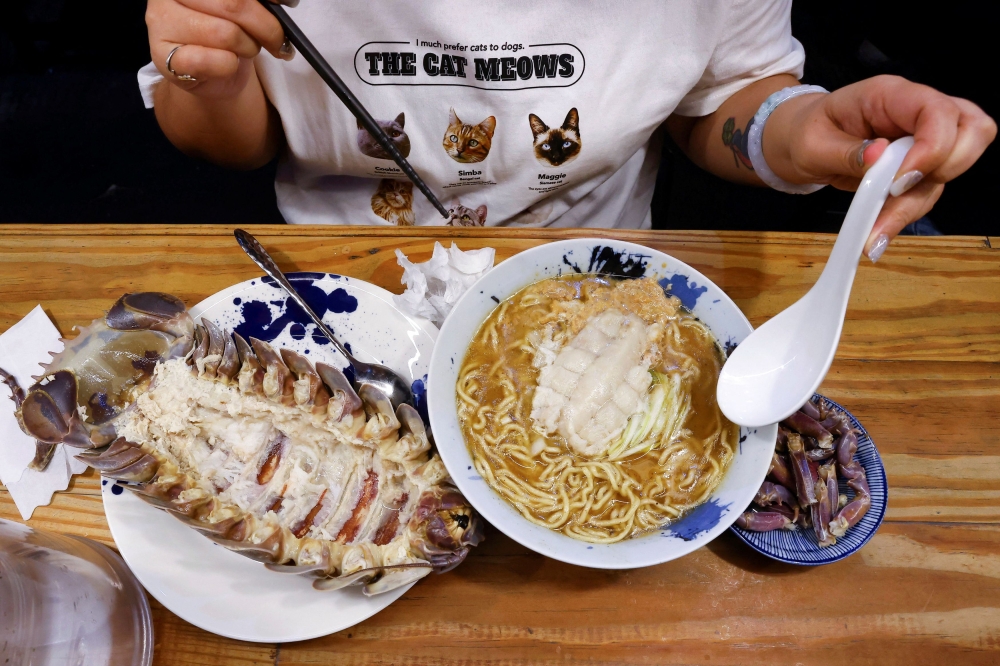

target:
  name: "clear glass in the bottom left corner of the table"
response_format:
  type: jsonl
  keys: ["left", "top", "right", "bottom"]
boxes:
{"left": 0, "top": 519, "right": 153, "bottom": 666}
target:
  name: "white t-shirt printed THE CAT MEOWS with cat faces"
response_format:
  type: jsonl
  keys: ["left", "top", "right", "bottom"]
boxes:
{"left": 139, "top": 0, "right": 805, "bottom": 228}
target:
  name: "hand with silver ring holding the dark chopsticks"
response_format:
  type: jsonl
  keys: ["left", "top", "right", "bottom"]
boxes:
{"left": 146, "top": 0, "right": 294, "bottom": 98}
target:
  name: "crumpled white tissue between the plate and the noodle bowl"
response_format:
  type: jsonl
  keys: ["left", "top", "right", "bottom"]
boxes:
{"left": 392, "top": 242, "right": 496, "bottom": 326}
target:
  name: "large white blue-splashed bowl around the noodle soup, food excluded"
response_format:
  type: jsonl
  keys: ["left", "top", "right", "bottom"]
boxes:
{"left": 427, "top": 238, "right": 777, "bottom": 569}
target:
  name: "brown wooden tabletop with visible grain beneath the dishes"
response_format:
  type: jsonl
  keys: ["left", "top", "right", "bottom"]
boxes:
{"left": 0, "top": 226, "right": 1000, "bottom": 666}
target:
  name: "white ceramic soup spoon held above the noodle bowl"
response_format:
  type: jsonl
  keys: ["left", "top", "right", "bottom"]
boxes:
{"left": 716, "top": 137, "right": 913, "bottom": 427}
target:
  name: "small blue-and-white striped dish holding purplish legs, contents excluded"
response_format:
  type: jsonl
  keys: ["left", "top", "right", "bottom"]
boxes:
{"left": 730, "top": 394, "right": 889, "bottom": 566}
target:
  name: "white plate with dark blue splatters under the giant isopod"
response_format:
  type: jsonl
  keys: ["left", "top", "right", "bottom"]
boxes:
{"left": 102, "top": 273, "right": 437, "bottom": 643}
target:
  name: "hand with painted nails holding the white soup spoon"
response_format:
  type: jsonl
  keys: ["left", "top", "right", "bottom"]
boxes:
{"left": 762, "top": 76, "right": 997, "bottom": 261}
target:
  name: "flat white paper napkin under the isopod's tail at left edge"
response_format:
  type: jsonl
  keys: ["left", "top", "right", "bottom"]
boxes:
{"left": 0, "top": 305, "right": 87, "bottom": 520}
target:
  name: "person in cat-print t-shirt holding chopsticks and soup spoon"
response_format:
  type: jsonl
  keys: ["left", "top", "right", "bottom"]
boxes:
{"left": 139, "top": 0, "right": 996, "bottom": 261}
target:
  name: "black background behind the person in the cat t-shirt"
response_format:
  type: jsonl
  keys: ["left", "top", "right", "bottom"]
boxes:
{"left": 0, "top": 0, "right": 1000, "bottom": 234}
